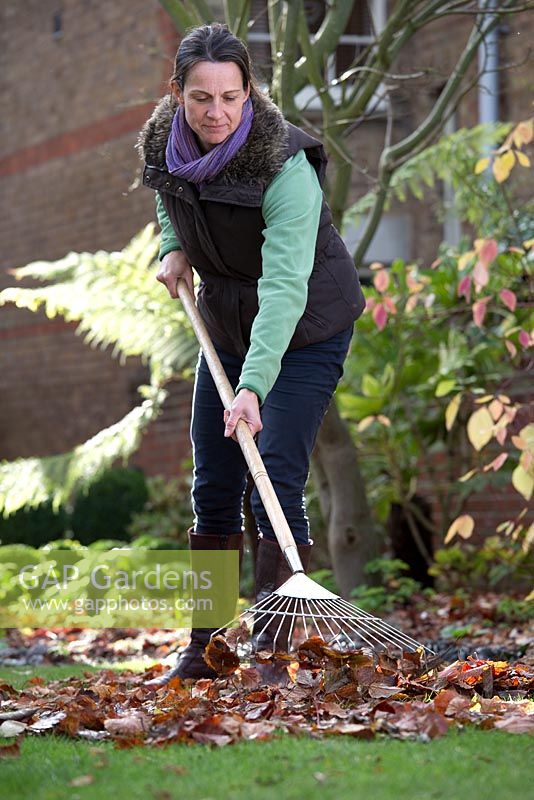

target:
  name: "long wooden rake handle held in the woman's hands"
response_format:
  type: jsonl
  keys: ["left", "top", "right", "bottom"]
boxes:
{"left": 177, "top": 278, "right": 304, "bottom": 573}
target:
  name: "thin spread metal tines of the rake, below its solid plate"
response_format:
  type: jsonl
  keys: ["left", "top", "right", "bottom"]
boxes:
{"left": 245, "top": 592, "right": 427, "bottom": 651}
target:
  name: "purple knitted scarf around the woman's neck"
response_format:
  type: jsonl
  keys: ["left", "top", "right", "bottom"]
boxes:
{"left": 165, "top": 97, "right": 254, "bottom": 184}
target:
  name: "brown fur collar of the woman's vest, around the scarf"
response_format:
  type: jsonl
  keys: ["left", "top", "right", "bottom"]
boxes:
{"left": 136, "top": 94, "right": 288, "bottom": 186}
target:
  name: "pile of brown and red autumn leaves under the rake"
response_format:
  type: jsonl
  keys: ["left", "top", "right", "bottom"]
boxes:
{"left": 0, "top": 638, "right": 534, "bottom": 755}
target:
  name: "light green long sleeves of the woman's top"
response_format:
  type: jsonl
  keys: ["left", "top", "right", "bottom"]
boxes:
{"left": 156, "top": 150, "right": 322, "bottom": 403}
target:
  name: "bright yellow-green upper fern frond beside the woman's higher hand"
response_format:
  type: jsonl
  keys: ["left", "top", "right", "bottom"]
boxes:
{"left": 0, "top": 225, "right": 198, "bottom": 375}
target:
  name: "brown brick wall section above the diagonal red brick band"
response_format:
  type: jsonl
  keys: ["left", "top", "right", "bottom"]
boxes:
{"left": 1, "top": 0, "right": 172, "bottom": 154}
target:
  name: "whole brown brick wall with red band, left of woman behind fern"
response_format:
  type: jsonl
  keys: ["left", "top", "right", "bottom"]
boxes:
{"left": 0, "top": 0, "right": 190, "bottom": 475}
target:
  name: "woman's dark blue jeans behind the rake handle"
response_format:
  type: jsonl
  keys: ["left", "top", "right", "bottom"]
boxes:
{"left": 191, "top": 326, "right": 352, "bottom": 544}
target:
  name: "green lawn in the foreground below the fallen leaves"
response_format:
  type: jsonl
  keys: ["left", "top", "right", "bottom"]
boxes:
{"left": 0, "top": 665, "right": 534, "bottom": 800}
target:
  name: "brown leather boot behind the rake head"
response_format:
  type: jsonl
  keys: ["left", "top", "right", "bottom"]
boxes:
{"left": 252, "top": 537, "right": 313, "bottom": 684}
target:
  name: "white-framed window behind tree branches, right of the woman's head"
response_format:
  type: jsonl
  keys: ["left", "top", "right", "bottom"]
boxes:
{"left": 248, "top": 0, "right": 386, "bottom": 110}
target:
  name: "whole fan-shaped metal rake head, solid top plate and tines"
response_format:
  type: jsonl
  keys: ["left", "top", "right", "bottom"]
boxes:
{"left": 214, "top": 572, "right": 433, "bottom": 655}
